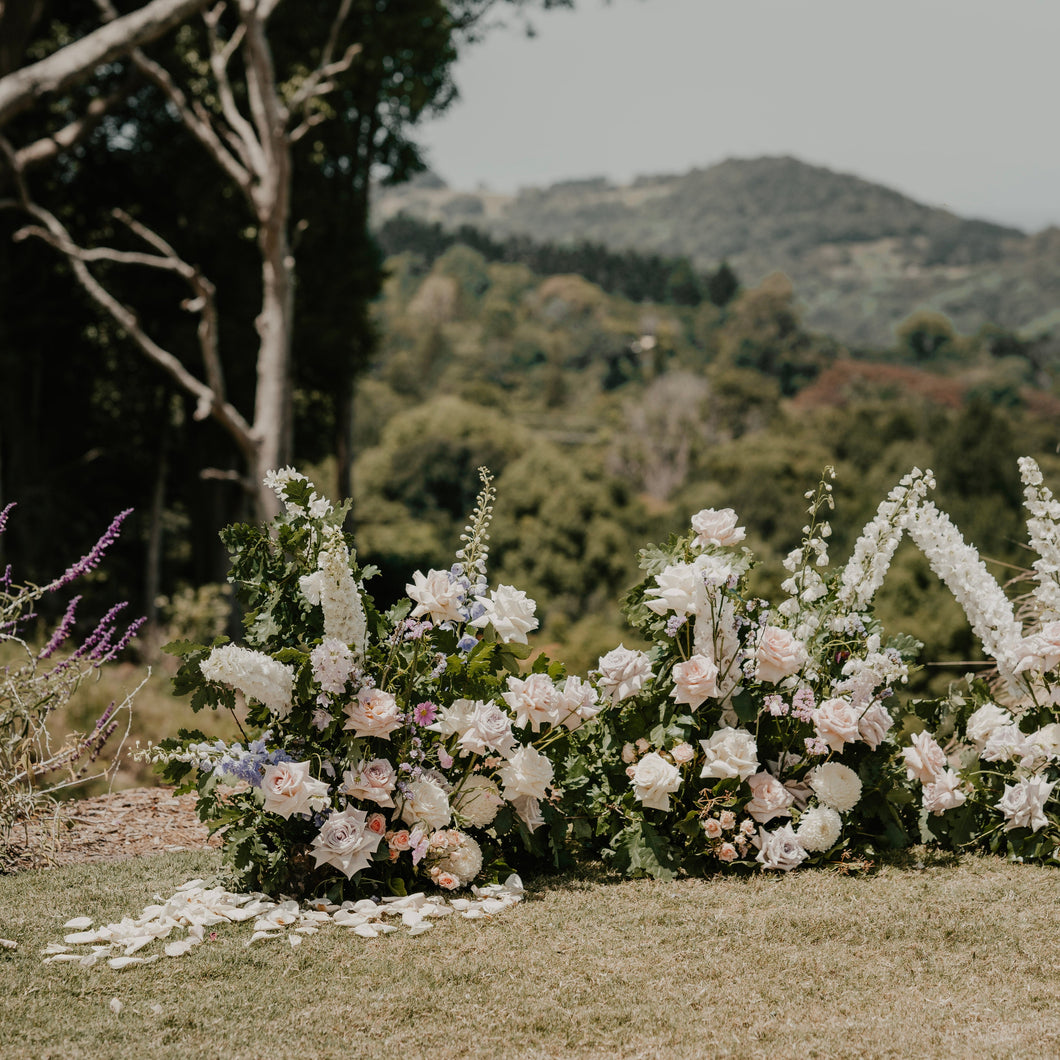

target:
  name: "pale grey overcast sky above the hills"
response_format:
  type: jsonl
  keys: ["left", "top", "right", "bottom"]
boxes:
{"left": 421, "top": 0, "right": 1060, "bottom": 231}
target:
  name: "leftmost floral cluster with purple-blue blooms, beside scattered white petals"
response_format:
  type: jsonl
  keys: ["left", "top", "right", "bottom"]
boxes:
{"left": 152, "top": 469, "right": 599, "bottom": 902}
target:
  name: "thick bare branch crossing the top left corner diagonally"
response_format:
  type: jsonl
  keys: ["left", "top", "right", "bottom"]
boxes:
{"left": 0, "top": 0, "right": 213, "bottom": 126}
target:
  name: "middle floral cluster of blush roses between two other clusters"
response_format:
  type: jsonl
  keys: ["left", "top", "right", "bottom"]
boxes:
{"left": 566, "top": 470, "right": 933, "bottom": 879}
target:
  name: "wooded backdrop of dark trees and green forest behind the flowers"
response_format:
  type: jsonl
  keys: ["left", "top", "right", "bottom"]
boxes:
{"left": 0, "top": 0, "right": 1060, "bottom": 703}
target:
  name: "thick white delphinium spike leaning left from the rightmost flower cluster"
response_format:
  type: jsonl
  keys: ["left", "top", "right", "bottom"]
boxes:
{"left": 904, "top": 501, "right": 1023, "bottom": 692}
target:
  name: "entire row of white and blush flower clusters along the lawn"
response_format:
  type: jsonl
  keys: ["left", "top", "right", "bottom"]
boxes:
{"left": 140, "top": 453, "right": 1060, "bottom": 903}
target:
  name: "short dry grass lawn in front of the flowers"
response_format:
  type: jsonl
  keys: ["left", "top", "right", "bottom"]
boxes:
{"left": 0, "top": 853, "right": 1060, "bottom": 1060}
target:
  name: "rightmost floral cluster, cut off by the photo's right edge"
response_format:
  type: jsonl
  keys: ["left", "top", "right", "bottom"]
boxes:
{"left": 902, "top": 457, "right": 1060, "bottom": 864}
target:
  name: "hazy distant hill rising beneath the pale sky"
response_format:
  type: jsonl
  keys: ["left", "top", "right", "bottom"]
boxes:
{"left": 373, "top": 157, "right": 1060, "bottom": 347}
